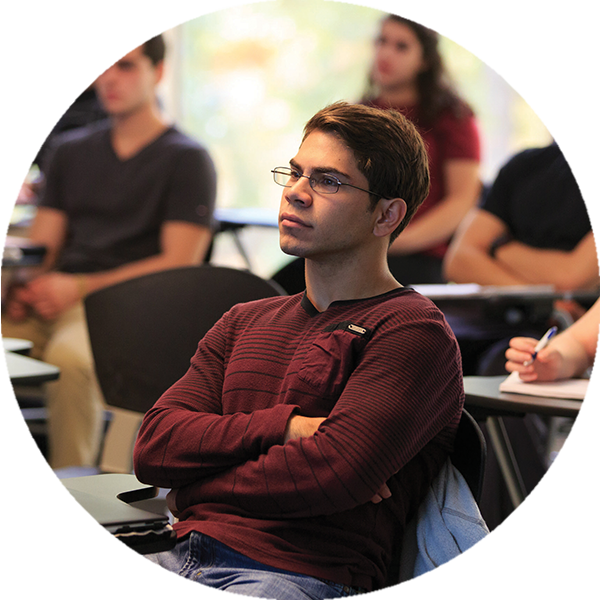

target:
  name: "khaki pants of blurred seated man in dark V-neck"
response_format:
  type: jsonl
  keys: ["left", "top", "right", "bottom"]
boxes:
{"left": 2, "top": 303, "right": 104, "bottom": 468}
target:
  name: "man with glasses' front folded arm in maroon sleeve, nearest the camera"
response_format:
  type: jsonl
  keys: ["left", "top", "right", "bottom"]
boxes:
{"left": 176, "top": 324, "right": 463, "bottom": 518}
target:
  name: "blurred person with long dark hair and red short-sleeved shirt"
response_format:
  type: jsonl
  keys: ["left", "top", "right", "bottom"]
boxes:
{"left": 362, "top": 8, "right": 481, "bottom": 285}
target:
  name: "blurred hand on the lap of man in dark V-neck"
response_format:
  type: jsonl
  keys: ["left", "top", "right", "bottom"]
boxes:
{"left": 27, "top": 272, "right": 82, "bottom": 320}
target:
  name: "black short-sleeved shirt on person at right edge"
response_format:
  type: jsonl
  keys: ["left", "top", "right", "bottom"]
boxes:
{"left": 482, "top": 142, "right": 600, "bottom": 252}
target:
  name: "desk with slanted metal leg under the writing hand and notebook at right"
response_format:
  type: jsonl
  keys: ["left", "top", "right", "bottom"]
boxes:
{"left": 464, "top": 375, "right": 600, "bottom": 526}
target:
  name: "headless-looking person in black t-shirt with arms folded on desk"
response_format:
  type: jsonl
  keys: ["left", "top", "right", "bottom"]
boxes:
{"left": 445, "top": 21, "right": 600, "bottom": 290}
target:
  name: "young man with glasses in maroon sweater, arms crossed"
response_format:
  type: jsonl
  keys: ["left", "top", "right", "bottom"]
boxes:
{"left": 80, "top": 103, "right": 464, "bottom": 600}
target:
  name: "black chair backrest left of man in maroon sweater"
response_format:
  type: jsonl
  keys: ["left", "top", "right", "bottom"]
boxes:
{"left": 85, "top": 265, "right": 281, "bottom": 413}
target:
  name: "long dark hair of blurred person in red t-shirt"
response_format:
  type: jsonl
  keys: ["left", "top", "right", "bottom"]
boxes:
{"left": 362, "top": 8, "right": 473, "bottom": 124}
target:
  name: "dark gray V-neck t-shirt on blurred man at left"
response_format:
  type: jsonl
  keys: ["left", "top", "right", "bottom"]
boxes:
{"left": 40, "top": 123, "right": 216, "bottom": 273}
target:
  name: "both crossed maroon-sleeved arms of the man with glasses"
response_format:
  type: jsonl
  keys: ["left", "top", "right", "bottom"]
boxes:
{"left": 134, "top": 304, "right": 462, "bottom": 518}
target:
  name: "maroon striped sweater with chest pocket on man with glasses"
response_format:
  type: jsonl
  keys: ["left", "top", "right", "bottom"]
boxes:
{"left": 134, "top": 288, "right": 464, "bottom": 589}
